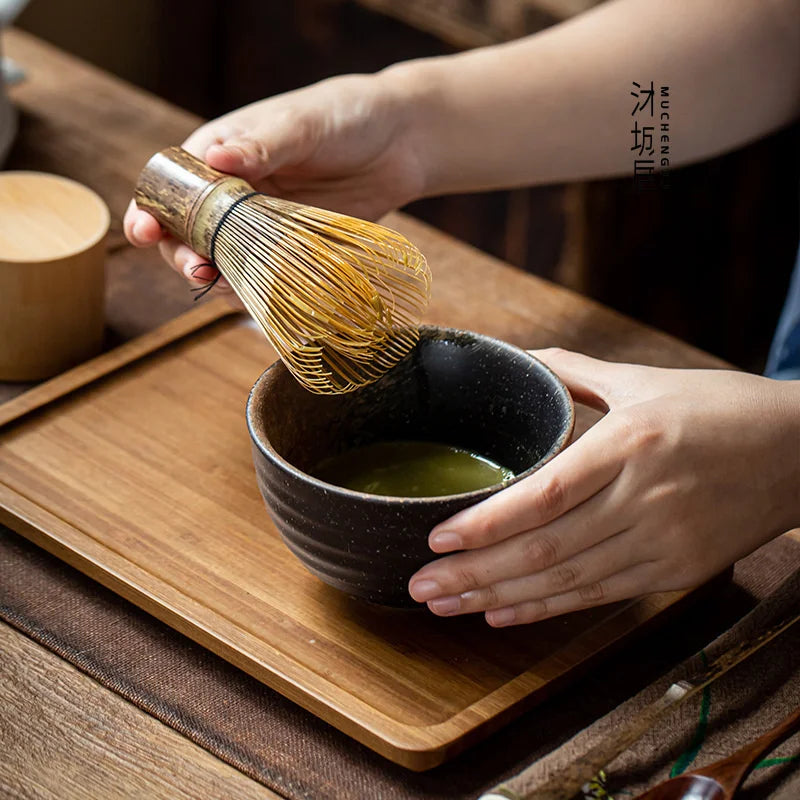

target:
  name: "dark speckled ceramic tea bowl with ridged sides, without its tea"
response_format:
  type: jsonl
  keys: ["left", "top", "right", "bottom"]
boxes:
{"left": 247, "top": 326, "right": 574, "bottom": 606}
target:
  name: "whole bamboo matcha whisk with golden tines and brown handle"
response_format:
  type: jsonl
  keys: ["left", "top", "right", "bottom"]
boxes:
{"left": 136, "top": 147, "right": 430, "bottom": 394}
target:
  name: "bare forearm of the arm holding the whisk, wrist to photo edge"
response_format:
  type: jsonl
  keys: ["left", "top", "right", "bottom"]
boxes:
{"left": 381, "top": 0, "right": 800, "bottom": 194}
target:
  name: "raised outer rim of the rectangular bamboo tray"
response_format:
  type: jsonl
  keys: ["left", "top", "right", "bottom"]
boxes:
{"left": 0, "top": 299, "right": 708, "bottom": 771}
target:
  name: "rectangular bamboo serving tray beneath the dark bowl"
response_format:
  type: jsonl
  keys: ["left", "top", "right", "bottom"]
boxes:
{"left": 0, "top": 301, "right": 708, "bottom": 770}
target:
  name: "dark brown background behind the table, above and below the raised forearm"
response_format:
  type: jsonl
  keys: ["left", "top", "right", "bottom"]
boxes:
{"left": 19, "top": 0, "right": 800, "bottom": 370}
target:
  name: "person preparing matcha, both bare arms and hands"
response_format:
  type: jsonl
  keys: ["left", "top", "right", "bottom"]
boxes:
{"left": 125, "top": 0, "right": 800, "bottom": 625}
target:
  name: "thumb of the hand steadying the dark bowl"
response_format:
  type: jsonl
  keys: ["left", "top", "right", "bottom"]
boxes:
{"left": 528, "top": 347, "right": 659, "bottom": 411}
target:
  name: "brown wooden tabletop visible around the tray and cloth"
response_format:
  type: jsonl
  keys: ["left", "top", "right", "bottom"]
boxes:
{"left": 0, "top": 31, "right": 736, "bottom": 800}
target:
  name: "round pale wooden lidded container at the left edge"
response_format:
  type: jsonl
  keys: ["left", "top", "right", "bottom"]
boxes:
{"left": 0, "top": 172, "right": 110, "bottom": 381}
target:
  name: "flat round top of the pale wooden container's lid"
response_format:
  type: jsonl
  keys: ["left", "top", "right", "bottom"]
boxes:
{"left": 0, "top": 171, "right": 110, "bottom": 263}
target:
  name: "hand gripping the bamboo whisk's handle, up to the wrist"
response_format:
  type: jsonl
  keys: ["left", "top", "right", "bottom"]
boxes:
{"left": 125, "top": 75, "right": 432, "bottom": 289}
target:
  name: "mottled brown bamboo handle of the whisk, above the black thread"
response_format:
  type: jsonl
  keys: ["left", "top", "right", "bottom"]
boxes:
{"left": 134, "top": 147, "right": 254, "bottom": 258}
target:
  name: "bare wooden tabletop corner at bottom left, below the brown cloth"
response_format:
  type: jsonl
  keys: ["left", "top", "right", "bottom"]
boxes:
{"left": 0, "top": 623, "right": 279, "bottom": 800}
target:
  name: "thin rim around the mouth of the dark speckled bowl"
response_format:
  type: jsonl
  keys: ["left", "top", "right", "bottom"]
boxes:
{"left": 246, "top": 325, "right": 575, "bottom": 506}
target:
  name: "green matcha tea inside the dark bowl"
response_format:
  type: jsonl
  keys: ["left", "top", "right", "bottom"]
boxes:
{"left": 313, "top": 442, "right": 514, "bottom": 497}
